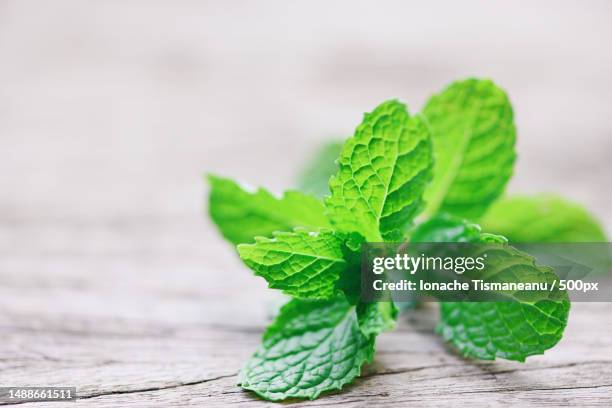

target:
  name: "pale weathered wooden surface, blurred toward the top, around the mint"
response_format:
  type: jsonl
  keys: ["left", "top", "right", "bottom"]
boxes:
{"left": 0, "top": 0, "right": 612, "bottom": 407}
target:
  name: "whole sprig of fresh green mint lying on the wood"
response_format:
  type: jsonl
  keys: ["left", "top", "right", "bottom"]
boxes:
{"left": 209, "top": 79, "right": 605, "bottom": 401}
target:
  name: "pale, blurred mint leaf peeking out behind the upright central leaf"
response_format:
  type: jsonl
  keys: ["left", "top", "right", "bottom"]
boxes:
{"left": 298, "top": 140, "right": 342, "bottom": 198}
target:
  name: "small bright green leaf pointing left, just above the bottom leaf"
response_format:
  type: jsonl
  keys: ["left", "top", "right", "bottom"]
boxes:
{"left": 238, "top": 229, "right": 347, "bottom": 299}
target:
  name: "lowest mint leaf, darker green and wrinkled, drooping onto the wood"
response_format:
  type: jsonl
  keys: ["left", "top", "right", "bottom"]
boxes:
{"left": 239, "top": 297, "right": 375, "bottom": 401}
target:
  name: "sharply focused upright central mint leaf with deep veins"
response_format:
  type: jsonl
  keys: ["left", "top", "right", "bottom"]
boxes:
{"left": 325, "top": 101, "right": 432, "bottom": 242}
